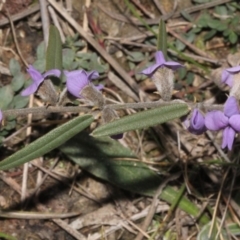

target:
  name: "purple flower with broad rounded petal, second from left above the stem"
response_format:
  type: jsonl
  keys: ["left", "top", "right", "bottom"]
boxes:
{"left": 64, "top": 70, "right": 103, "bottom": 98}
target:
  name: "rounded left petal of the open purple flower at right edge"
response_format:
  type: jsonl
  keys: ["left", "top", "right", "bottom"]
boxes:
{"left": 205, "top": 111, "right": 228, "bottom": 131}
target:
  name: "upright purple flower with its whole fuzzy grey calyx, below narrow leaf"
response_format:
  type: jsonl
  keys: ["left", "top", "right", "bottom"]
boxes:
{"left": 141, "top": 51, "right": 182, "bottom": 101}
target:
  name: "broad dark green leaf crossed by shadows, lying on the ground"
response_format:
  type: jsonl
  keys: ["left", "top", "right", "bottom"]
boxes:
{"left": 60, "top": 132, "right": 209, "bottom": 224}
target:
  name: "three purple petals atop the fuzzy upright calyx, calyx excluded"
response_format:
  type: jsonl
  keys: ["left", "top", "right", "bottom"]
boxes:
{"left": 141, "top": 51, "right": 182, "bottom": 77}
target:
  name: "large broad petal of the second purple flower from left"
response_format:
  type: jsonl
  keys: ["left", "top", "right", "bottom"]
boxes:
{"left": 64, "top": 70, "right": 89, "bottom": 98}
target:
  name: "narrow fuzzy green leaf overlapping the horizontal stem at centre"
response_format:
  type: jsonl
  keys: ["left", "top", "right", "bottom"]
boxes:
{"left": 92, "top": 103, "right": 189, "bottom": 137}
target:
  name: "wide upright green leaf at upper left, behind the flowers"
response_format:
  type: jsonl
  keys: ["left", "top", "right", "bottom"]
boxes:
{"left": 46, "top": 26, "right": 62, "bottom": 71}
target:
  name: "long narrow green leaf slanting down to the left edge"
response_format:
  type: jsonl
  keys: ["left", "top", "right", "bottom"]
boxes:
{"left": 0, "top": 115, "right": 93, "bottom": 170}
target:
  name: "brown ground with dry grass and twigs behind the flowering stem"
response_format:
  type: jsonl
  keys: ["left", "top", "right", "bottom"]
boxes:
{"left": 0, "top": 0, "right": 240, "bottom": 240}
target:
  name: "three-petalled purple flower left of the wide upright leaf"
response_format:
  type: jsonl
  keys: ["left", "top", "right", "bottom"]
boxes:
{"left": 21, "top": 65, "right": 61, "bottom": 96}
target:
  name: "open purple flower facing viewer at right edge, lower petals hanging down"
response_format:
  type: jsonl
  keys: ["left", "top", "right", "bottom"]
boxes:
{"left": 205, "top": 97, "right": 240, "bottom": 150}
